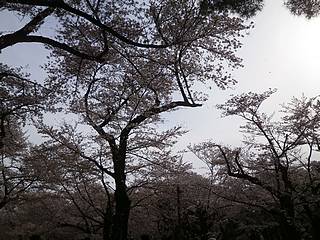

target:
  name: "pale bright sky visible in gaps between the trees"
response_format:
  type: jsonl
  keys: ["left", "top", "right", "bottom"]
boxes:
{"left": 0, "top": 0, "right": 320, "bottom": 172}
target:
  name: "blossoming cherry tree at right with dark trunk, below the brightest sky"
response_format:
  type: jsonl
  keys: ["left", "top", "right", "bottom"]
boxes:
{"left": 193, "top": 90, "right": 320, "bottom": 239}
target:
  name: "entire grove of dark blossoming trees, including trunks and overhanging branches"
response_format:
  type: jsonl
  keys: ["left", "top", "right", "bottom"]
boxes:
{"left": 0, "top": 0, "right": 320, "bottom": 240}
